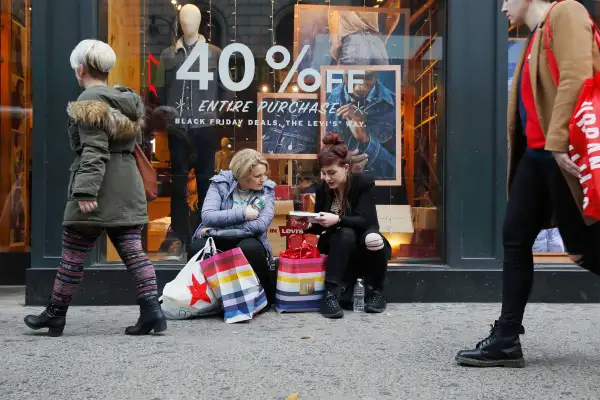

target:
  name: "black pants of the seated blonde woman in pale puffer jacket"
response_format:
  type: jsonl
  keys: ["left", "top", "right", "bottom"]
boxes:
{"left": 188, "top": 237, "right": 275, "bottom": 304}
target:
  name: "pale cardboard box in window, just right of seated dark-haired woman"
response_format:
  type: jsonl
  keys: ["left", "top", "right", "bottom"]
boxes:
{"left": 376, "top": 205, "right": 414, "bottom": 259}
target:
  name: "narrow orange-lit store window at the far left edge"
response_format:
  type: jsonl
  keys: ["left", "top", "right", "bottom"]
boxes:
{"left": 0, "top": 0, "right": 32, "bottom": 252}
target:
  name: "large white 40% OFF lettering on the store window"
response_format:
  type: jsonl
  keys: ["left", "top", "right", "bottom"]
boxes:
{"left": 176, "top": 43, "right": 365, "bottom": 93}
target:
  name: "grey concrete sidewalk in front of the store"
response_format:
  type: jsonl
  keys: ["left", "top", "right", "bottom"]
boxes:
{"left": 0, "top": 290, "right": 600, "bottom": 400}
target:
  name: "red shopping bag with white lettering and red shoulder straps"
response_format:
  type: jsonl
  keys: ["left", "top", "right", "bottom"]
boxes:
{"left": 544, "top": 3, "right": 600, "bottom": 220}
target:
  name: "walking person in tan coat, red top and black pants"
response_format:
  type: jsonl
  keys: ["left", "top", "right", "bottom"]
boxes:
{"left": 456, "top": 0, "right": 600, "bottom": 367}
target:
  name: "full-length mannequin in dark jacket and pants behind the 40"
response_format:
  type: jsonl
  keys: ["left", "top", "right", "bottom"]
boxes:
{"left": 154, "top": 4, "right": 233, "bottom": 259}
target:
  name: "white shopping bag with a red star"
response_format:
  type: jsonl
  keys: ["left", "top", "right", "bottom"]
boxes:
{"left": 159, "top": 238, "right": 223, "bottom": 319}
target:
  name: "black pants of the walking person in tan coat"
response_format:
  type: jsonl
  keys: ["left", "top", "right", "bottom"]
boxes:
{"left": 500, "top": 153, "right": 600, "bottom": 329}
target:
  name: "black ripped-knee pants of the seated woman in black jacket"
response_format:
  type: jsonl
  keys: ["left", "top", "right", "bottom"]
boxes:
{"left": 318, "top": 227, "right": 391, "bottom": 294}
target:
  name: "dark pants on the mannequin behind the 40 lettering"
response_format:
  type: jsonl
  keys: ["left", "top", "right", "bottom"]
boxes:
{"left": 167, "top": 126, "right": 217, "bottom": 246}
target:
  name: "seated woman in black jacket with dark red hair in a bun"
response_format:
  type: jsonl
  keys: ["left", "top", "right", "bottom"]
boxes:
{"left": 305, "top": 134, "right": 391, "bottom": 318}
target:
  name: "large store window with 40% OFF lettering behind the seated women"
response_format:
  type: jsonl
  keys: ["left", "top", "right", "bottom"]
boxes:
{"left": 101, "top": 0, "right": 446, "bottom": 264}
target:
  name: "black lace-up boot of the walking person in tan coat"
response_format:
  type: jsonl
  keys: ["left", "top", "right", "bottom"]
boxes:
{"left": 456, "top": 321, "right": 525, "bottom": 368}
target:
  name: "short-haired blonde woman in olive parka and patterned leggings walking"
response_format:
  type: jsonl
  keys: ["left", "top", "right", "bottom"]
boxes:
{"left": 25, "top": 40, "right": 167, "bottom": 336}
